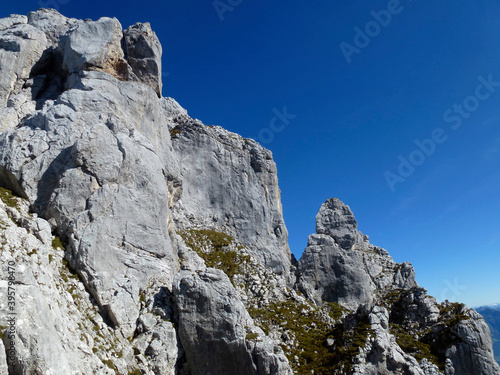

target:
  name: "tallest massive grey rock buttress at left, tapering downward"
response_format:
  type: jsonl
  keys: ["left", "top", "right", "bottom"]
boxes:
{"left": 0, "top": 11, "right": 176, "bottom": 335}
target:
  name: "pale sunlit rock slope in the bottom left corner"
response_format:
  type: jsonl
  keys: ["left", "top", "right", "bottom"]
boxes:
{"left": 0, "top": 190, "right": 126, "bottom": 375}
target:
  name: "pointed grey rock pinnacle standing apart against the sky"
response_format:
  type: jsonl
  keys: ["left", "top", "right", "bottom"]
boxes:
{"left": 299, "top": 198, "right": 417, "bottom": 309}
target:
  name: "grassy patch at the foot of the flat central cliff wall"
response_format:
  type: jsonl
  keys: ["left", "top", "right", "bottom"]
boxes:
{"left": 179, "top": 229, "right": 250, "bottom": 282}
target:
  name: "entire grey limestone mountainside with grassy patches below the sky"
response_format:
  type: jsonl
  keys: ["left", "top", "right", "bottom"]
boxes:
{"left": 0, "top": 10, "right": 500, "bottom": 375}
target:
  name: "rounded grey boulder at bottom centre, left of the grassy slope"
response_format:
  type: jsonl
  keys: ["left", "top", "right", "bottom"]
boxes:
{"left": 173, "top": 268, "right": 292, "bottom": 375}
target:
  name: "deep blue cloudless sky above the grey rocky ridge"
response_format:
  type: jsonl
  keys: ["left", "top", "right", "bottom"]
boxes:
{"left": 0, "top": 0, "right": 500, "bottom": 306}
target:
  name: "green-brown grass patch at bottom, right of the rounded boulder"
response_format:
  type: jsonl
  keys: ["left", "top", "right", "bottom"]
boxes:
{"left": 248, "top": 300, "right": 350, "bottom": 375}
